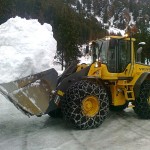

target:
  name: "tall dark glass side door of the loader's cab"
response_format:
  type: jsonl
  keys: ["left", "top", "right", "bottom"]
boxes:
{"left": 107, "top": 39, "right": 131, "bottom": 73}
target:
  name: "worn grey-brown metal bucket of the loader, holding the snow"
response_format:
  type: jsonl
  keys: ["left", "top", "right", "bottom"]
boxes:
{"left": 0, "top": 69, "right": 58, "bottom": 116}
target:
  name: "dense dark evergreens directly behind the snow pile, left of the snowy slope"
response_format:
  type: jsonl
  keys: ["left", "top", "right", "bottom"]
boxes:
{"left": 0, "top": 0, "right": 105, "bottom": 63}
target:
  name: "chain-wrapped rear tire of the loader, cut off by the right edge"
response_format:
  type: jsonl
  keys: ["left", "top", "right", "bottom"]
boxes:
{"left": 133, "top": 80, "right": 150, "bottom": 119}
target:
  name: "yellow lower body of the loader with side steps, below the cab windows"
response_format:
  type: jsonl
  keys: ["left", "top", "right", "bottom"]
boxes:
{"left": 88, "top": 63, "right": 150, "bottom": 106}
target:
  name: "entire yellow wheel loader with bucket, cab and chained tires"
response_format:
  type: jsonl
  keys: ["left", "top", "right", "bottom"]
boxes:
{"left": 0, "top": 36, "right": 150, "bottom": 129}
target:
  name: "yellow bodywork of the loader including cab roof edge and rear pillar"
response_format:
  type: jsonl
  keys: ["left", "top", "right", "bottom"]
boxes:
{"left": 77, "top": 36, "right": 150, "bottom": 106}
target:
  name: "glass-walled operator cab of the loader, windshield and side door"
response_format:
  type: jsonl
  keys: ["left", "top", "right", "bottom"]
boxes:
{"left": 91, "top": 37, "right": 131, "bottom": 73}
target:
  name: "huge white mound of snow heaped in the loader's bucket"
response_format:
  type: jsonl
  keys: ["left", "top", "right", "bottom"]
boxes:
{"left": 0, "top": 17, "right": 57, "bottom": 83}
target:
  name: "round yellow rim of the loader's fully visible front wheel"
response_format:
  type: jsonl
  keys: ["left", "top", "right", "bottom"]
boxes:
{"left": 82, "top": 96, "right": 100, "bottom": 117}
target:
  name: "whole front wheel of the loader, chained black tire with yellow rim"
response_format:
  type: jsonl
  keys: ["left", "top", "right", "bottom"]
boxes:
{"left": 62, "top": 80, "right": 109, "bottom": 129}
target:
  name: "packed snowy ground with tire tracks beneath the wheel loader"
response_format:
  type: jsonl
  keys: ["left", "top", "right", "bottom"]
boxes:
{"left": 0, "top": 95, "right": 150, "bottom": 150}
